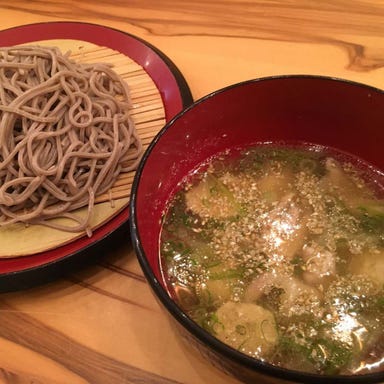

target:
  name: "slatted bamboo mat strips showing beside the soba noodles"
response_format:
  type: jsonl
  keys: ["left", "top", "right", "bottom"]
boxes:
{"left": 62, "top": 42, "right": 165, "bottom": 203}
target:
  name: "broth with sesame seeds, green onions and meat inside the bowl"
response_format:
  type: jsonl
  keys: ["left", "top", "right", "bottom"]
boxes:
{"left": 161, "top": 146, "right": 384, "bottom": 375}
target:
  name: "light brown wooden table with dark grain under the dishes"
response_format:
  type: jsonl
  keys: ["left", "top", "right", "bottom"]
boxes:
{"left": 0, "top": 0, "right": 384, "bottom": 384}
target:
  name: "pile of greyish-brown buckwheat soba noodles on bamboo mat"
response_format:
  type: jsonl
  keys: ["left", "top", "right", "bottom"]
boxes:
{"left": 0, "top": 46, "right": 142, "bottom": 235}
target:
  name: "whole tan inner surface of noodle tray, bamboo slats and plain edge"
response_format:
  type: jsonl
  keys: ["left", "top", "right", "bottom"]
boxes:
{"left": 0, "top": 39, "right": 165, "bottom": 255}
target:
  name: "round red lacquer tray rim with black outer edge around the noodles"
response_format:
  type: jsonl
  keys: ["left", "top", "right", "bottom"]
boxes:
{"left": 0, "top": 22, "right": 193, "bottom": 292}
